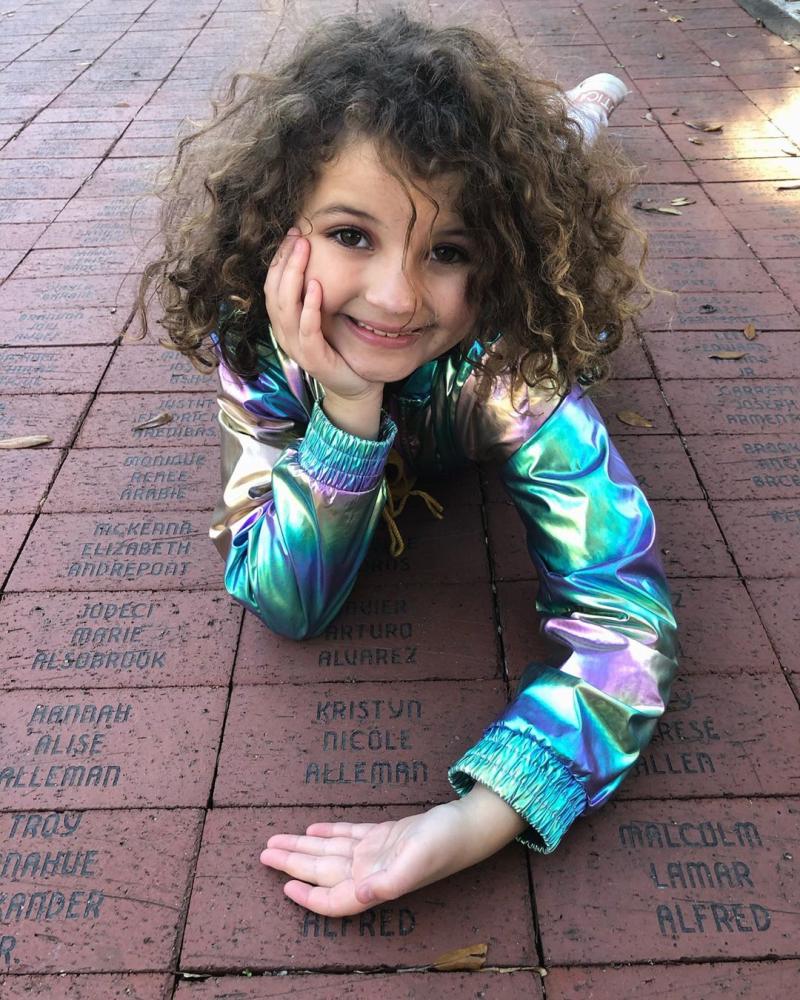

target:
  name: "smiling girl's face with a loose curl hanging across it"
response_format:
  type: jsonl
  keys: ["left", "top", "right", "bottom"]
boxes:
{"left": 296, "top": 140, "right": 477, "bottom": 382}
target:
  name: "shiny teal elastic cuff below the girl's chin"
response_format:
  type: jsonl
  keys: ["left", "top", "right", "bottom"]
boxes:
{"left": 297, "top": 403, "right": 397, "bottom": 493}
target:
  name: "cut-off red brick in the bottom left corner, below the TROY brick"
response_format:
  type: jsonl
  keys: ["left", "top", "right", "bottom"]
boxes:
{"left": 0, "top": 972, "right": 172, "bottom": 1000}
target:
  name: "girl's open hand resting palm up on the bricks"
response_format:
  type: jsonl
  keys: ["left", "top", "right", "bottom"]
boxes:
{"left": 261, "top": 802, "right": 476, "bottom": 917}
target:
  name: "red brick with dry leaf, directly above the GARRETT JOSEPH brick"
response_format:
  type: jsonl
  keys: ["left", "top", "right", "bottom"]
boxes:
{"left": 644, "top": 336, "right": 800, "bottom": 380}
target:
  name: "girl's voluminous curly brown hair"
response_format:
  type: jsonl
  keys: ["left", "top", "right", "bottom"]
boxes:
{"left": 131, "top": 11, "right": 651, "bottom": 392}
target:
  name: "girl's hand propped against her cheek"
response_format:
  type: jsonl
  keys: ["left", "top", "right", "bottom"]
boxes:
{"left": 264, "top": 227, "right": 383, "bottom": 402}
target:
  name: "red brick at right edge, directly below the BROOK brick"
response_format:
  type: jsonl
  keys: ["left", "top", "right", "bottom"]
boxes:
{"left": 712, "top": 500, "right": 800, "bottom": 578}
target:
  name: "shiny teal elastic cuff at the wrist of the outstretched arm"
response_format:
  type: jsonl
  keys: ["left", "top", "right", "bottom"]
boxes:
{"left": 447, "top": 726, "right": 586, "bottom": 854}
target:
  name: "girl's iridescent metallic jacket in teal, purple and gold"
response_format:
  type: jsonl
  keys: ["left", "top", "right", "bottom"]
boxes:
{"left": 211, "top": 328, "right": 676, "bottom": 852}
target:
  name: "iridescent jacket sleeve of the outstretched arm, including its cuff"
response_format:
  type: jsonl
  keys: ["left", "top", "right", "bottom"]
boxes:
{"left": 449, "top": 389, "right": 676, "bottom": 853}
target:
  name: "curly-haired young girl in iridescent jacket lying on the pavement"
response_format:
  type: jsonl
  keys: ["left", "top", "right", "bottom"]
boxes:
{"left": 140, "top": 13, "right": 675, "bottom": 915}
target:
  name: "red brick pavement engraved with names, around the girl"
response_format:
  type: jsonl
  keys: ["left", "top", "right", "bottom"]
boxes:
{"left": 0, "top": 0, "right": 800, "bottom": 1000}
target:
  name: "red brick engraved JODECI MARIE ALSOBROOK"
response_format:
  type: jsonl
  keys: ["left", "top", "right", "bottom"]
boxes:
{"left": 0, "top": 591, "right": 242, "bottom": 690}
